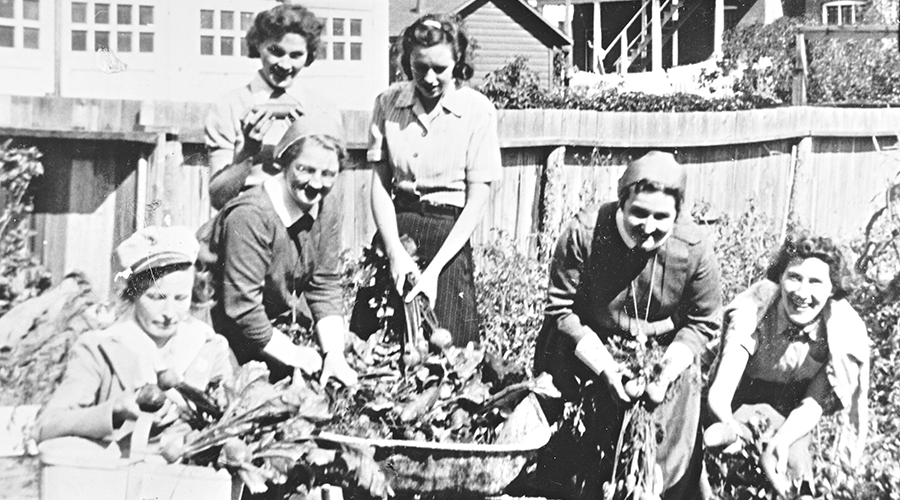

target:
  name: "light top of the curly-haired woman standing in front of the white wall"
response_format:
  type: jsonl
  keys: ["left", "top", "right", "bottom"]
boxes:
{"left": 205, "top": 72, "right": 341, "bottom": 174}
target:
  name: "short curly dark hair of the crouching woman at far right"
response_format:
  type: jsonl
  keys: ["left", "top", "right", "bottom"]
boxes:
{"left": 766, "top": 233, "right": 850, "bottom": 300}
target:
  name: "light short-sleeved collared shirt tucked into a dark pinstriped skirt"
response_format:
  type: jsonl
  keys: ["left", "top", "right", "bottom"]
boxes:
{"left": 367, "top": 82, "right": 503, "bottom": 207}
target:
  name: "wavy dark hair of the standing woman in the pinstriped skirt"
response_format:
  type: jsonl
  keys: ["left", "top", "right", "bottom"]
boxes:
{"left": 400, "top": 14, "right": 475, "bottom": 81}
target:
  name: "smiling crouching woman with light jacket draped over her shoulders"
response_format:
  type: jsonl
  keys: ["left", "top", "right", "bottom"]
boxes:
{"left": 705, "top": 235, "right": 869, "bottom": 496}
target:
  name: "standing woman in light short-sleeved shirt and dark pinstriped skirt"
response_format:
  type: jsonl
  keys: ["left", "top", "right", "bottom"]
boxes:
{"left": 356, "top": 15, "right": 502, "bottom": 346}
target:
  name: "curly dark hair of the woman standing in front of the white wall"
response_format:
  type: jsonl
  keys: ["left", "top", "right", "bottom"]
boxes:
{"left": 247, "top": 4, "right": 325, "bottom": 66}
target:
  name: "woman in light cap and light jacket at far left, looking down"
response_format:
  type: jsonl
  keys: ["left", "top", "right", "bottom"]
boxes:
{"left": 35, "top": 226, "right": 236, "bottom": 445}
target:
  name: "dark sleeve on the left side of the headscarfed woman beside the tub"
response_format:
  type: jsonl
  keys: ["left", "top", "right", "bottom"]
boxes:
{"left": 219, "top": 205, "right": 274, "bottom": 350}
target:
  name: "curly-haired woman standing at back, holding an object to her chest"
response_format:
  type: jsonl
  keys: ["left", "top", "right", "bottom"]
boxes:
{"left": 206, "top": 3, "right": 343, "bottom": 210}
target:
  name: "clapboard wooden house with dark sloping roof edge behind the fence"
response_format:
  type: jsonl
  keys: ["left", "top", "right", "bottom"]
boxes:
{"left": 390, "top": 0, "right": 572, "bottom": 85}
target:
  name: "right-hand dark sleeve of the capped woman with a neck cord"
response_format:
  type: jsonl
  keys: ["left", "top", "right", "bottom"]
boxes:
{"left": 675, "top": 241, "right": 722, "bottom": 355}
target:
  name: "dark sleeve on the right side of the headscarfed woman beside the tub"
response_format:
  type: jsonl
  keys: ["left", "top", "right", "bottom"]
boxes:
{"left": 303, "top": 188, "right": 343, "bottom": 322}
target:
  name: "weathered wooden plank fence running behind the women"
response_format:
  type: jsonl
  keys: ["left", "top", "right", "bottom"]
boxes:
{"left": 0, "top": 96, "right": 900, "bottom": 292}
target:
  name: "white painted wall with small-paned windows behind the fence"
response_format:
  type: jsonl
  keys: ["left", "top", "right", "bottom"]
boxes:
{"left": 0, "top": 0, "right": 388, "bottom": 110}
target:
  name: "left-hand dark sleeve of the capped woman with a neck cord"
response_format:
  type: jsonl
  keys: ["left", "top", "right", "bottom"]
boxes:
{"left": 545, "top": 218, "right": 591, "bottom": 339}
